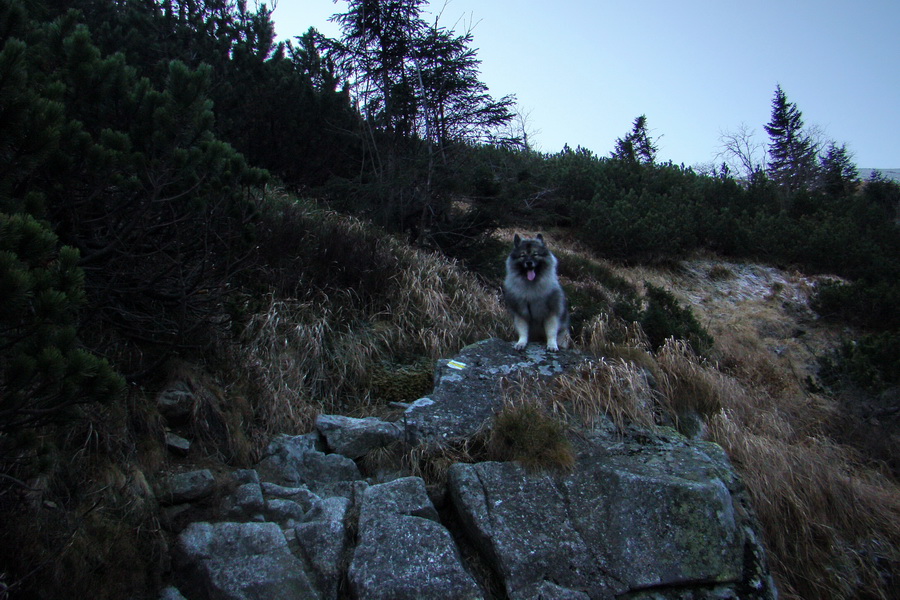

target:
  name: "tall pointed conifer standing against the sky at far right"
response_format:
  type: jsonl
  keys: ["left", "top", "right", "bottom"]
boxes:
{"left": 765, "top": 85, "right": 816, "bottom": 192}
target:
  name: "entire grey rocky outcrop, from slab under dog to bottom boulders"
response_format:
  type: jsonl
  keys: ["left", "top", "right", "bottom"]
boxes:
{"left": 163, "top": 340, "right": 777, "bottom": 600}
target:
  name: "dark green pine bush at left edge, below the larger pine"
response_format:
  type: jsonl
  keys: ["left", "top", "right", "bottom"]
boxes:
{"left": 0, "top": 213, "right": 124, "bottom": 438}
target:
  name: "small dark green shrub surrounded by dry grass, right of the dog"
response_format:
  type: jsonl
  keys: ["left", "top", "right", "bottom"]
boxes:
{"left": 638, "top": 283, "right": 713, "bottom": 354}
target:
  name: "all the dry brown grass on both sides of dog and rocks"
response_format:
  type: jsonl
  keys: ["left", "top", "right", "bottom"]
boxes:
{"left": 193, "top": 209, "right": 900, "bottom": 600}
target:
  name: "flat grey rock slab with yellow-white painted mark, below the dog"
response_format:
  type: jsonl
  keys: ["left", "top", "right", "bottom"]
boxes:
{"left": 404, "top": 338, "right": 589, "bottom": 443}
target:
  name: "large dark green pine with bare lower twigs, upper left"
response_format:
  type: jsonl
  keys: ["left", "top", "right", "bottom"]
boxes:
{"left": 0, "top": 0, "right": 265, "bottom": 360}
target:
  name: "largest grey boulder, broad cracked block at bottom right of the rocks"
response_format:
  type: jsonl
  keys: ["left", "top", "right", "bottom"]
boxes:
{"left": 450, "top": 436, "right": 756, "bottom": 599}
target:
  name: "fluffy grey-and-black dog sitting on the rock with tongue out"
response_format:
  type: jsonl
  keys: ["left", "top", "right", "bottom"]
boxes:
{"left": 503, "top": 233, "right": 569, "bottom": 352}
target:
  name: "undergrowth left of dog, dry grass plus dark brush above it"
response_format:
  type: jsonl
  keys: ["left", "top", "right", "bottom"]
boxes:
{"left": 227, "top": 192, "right": 506, "bottom": 440}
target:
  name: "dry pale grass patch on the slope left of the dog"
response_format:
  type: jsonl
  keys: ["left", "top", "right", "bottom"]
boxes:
{"left": 228, "top": 198, "right": 507, "bottom": 439}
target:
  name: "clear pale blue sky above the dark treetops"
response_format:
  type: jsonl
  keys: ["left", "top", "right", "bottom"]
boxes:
{"left": 272, "top": 0, "right": 900, "bottom": 169}
